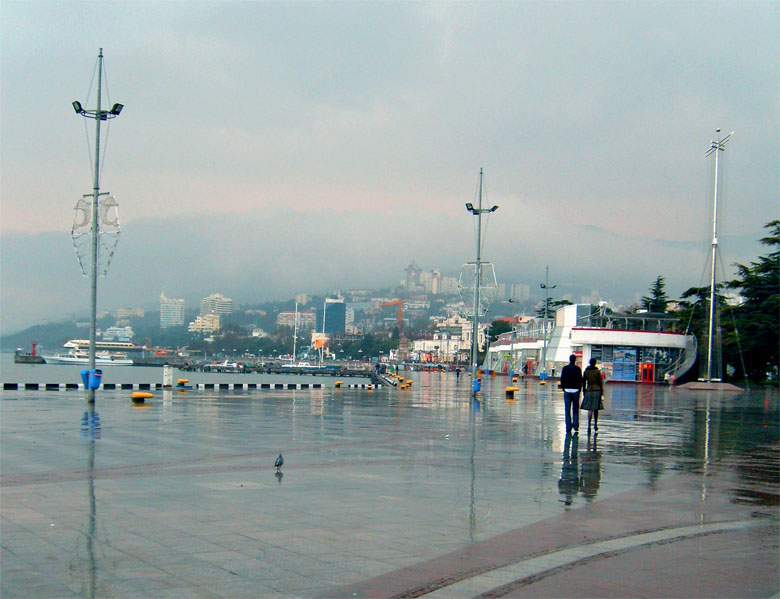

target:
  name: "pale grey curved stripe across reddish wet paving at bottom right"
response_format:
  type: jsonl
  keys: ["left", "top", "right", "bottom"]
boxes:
{"left": 414, "top": 518, "right": 777, "bottom": 599}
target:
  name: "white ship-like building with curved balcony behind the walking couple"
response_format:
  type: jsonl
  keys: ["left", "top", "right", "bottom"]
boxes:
{"left": 482, "top": 304, "right": 698, "bottom": 383}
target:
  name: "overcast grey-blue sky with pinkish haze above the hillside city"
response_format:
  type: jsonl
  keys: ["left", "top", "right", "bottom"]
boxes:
{"left": 0, "top": 0, "right": 780, "bottom": 332}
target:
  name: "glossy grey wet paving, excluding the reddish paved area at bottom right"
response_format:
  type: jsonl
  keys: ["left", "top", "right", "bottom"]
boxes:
{"left": 0, "top": 372, "right": 780, "bottom": 597}
